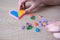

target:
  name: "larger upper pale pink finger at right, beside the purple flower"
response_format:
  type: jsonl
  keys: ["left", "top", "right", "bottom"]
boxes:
{"left": 45, "top": 22, "right": 60, "bottom": 33}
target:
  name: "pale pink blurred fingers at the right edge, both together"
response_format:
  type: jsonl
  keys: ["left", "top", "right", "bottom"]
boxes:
{"left": 46, "top": 21, "right": 60, "bottom": 39}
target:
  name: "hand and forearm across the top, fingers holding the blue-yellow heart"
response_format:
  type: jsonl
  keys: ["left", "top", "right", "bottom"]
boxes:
{"left": 19, "top": 0, "right": 60, "bottom": 13}
